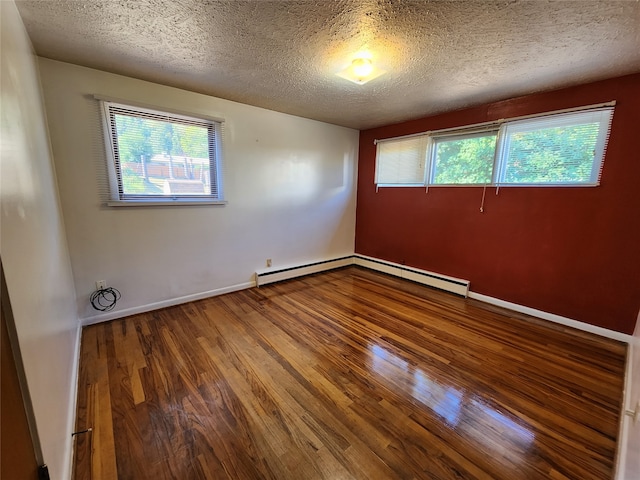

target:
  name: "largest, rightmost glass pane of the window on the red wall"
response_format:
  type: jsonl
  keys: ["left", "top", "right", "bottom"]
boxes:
{"left": 501, "top": 111, "right": 610, "bottom": 184}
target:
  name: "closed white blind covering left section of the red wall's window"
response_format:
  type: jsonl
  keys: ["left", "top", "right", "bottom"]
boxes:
{"left": 375, "top": 135, "right": 429, "bottom": 186}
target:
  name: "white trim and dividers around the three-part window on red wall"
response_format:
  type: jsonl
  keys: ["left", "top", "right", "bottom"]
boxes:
{"left": 373, "top": 100, "right": 616, "bottom": 191}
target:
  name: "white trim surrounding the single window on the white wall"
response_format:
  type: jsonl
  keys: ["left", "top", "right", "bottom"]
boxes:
{"left": 93, "top": 95, "right": 228, "bottom": 207}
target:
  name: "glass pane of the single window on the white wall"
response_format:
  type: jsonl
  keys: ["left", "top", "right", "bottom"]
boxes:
{"left": 113, "top": 114, "right": 211, "bottom": 196}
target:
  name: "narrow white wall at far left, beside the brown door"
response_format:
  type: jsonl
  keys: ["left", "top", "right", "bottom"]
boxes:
{"left": 0, "top": 1, "right": 79, "bottom": 479}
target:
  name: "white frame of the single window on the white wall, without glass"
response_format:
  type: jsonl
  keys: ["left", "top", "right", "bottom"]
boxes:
{"left": 100, "top": 96, "right": 227, "bottom": 207}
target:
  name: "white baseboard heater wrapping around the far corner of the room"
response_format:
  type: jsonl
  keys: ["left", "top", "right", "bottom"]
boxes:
{"left": 255, "top": 255, "right": 470, "bottom": 297}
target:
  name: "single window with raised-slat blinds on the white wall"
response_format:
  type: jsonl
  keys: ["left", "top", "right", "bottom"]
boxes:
{"left": 102, "top": 101, "right": 222, "bottom": 205}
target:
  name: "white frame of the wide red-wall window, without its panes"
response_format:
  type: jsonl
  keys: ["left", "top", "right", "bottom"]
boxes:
{"left": 374, "top": 101, "right": 615, "bottom": 190}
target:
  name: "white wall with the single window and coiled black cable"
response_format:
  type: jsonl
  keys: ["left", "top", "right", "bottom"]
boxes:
{"left": 40, "top": 59, "right": 358, "bottom": 322}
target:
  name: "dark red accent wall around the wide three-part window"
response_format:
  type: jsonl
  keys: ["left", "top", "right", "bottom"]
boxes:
{"left": 356, "top": 74, "right": 640, "bottom": 334}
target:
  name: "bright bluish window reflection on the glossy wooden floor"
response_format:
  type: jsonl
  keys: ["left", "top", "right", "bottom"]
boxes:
{"left": 369, "top": 345, "right": 535, "bottom": 454}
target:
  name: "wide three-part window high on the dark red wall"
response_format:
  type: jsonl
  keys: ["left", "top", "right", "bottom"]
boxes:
{"left": 375, "top": 106, "right": 613, "bottom": 186}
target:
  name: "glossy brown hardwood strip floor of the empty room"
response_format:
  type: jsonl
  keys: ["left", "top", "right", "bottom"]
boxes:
{"left": 75, "top": 267, "right": 626, "bottom": 480}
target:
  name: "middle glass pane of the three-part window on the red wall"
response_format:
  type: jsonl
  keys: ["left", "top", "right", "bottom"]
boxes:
{"left": 432, "top": 133, "right": 497, "bottom": 185}
